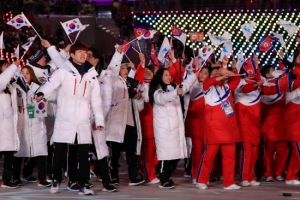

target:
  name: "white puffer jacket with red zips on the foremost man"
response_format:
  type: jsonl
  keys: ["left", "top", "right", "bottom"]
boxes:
{"left": 37, "top": 46, "right": 104, "bottom": 144}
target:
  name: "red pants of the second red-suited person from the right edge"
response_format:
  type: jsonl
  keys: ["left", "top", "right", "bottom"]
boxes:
{"left": 264, "top": 141, "right": 289, "bottom": 177}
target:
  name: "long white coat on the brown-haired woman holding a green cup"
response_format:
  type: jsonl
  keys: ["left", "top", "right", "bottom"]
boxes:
{"left": 14, "top": 83, "right": 48, "bottom": 157}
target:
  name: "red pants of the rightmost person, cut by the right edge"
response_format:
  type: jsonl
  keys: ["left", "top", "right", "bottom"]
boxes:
{"left": 286, "top": 141, "right": 300, "bottom": 181}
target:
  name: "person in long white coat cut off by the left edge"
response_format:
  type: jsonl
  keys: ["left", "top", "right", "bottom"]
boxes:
{"left": 0, "top": 60, "right": 20, "bottom": 188}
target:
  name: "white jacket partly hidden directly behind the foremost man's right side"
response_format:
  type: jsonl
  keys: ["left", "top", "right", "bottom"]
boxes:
{"left": 93, "top": 70, "right": 112, "bottom": 160}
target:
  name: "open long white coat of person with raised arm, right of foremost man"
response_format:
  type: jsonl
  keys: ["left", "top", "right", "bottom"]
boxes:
{"left": 106, "top": 51, "right": 144, "bottom": 155}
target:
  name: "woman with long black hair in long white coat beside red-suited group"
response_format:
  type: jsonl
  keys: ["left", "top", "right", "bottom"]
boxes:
{"left": 149, "top": 68, "right": 197, "bottom": 189}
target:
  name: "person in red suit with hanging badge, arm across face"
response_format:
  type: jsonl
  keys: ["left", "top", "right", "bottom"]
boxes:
{"left": 197, "top": 67, "right": 240, "bottom": 190}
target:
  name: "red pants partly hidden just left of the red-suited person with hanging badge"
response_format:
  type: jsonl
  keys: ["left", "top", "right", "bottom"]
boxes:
{"left": 192, "top": 138, "right": 204, "bottom": 179}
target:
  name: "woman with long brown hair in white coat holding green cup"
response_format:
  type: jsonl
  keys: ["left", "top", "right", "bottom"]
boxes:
{"left": 13, "top": 66, "right": 51, "bottom": 187}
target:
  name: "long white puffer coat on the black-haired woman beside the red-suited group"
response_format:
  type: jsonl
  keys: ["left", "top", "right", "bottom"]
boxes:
{"left": 153, "top": 74, "right": 197, "bottom": 160}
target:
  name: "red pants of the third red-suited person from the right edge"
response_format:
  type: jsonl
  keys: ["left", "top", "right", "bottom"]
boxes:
{"left": 240, "top": 143, "right": 258, "bottom": 182}
